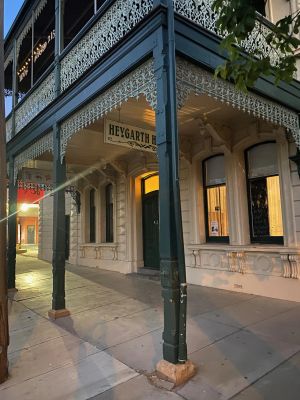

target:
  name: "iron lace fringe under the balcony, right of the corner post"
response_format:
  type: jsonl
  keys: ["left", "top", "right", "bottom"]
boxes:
{"left": 176, "top": 58, "right": 300, "bottom": 148}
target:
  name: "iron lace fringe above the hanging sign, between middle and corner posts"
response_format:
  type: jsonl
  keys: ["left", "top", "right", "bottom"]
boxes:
{"left": 61, "top": 59, "right": 157, "bottom": 159}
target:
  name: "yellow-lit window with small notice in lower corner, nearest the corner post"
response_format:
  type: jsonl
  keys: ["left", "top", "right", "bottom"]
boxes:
{"left": 203, "top": 155, "right": 229, "bottom": 242}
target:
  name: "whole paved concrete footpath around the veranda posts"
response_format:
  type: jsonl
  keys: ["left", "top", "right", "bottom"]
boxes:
{"left": 0, "top": 256, "right": 300, "bottom": 400}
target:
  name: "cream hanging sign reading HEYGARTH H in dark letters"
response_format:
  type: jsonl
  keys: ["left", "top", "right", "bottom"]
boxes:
{"left": 104, "top": 119, "right": 157, "bottom": 153}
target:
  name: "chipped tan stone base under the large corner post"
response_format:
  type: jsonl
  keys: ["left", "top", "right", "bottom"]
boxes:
{"left": 156, "top": 360, "right": 197, "bottom": 386}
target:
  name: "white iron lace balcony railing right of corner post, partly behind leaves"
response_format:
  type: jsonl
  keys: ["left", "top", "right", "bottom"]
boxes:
{"left": 173, "top": 0, "right": 280, "bottom": 65}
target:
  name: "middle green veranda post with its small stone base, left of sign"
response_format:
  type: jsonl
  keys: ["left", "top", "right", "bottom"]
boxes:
{"left": 48, "top": 124, "right": 70, "bottom": 319}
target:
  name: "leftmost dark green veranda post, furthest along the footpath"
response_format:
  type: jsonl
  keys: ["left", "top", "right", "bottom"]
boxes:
{"left": 7, "top": 157, "right": 18, "bottom": 291}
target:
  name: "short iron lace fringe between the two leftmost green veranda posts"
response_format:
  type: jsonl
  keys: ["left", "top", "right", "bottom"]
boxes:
{"left": 14, "top": 132, "right": 53, "bottom": 182}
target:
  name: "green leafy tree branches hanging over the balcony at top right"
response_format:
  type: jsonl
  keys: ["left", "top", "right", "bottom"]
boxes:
{"left": 213, "top": 0, "right": 300, "bottom": 90}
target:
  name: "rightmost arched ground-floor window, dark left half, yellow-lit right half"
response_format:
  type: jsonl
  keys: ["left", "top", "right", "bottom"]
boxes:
{"left": 246, "top": 142, "right": 283, "bottom": 244}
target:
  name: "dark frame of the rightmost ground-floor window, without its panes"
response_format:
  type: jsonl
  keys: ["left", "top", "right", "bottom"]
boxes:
{"left": 244, "top": 140, "right": 284, "bottom": 245}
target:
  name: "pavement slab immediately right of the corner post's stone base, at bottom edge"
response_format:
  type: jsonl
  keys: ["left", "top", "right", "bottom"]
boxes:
{"left": 178, "top": 330, "right": 300, "bottom": 400}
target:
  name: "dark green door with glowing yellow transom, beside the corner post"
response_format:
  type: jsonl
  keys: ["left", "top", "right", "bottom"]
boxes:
{"left": 142, "top": 173, "right": 160, "bottom": 270}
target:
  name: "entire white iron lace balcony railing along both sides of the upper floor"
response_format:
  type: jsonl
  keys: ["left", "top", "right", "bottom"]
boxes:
{"left": 6, "top": 0, "right": 279, "bottom": 141}
